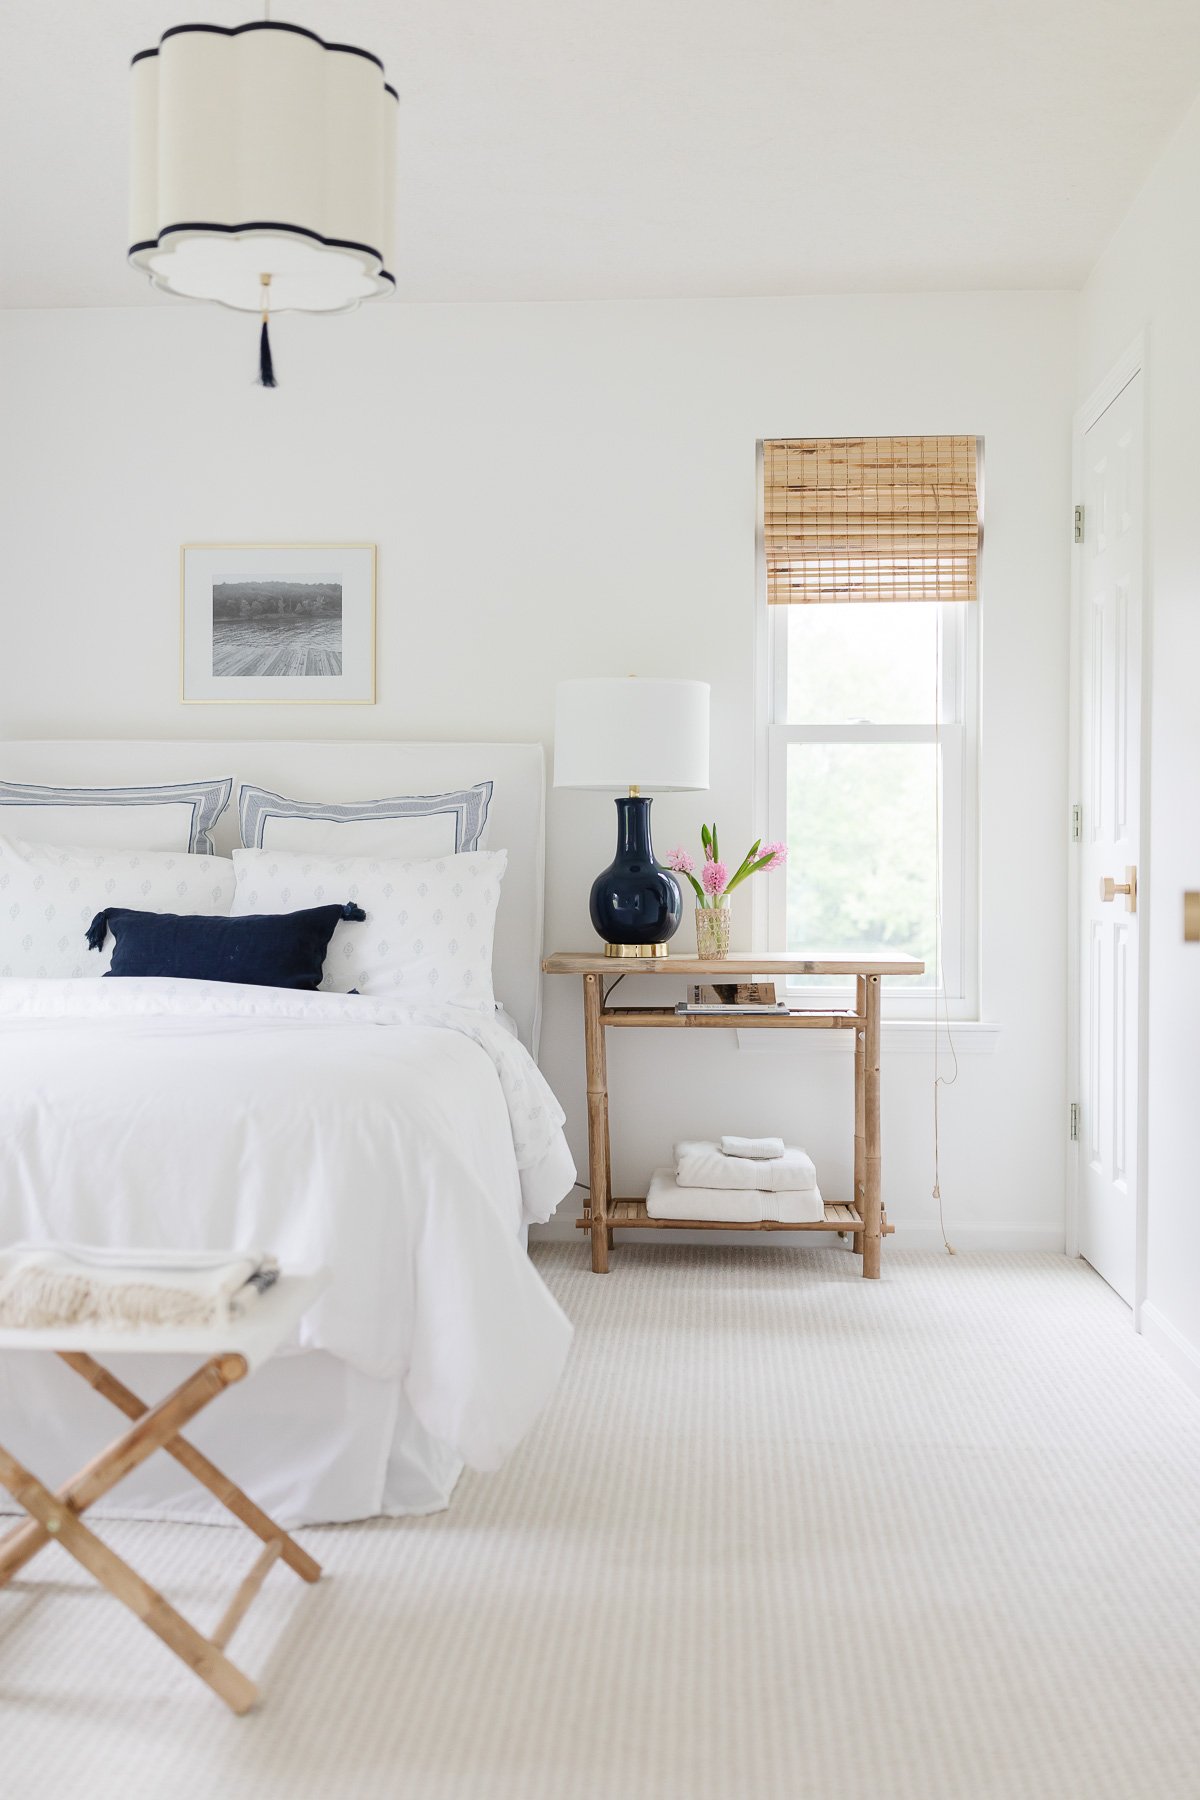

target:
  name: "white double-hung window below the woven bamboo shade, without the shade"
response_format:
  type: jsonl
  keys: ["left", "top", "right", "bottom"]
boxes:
{"left": 759, "top": 439, "right": 979, "bottom": 1017}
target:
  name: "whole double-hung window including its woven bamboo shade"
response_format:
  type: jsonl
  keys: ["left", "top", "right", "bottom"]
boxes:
{"left": 763, "top": 437, "right": 981, "bottom": 1017}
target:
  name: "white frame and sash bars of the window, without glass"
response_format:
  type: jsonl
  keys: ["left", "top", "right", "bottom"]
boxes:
{"left": 752, "top": 478, "right": 979, "bottom": 1019}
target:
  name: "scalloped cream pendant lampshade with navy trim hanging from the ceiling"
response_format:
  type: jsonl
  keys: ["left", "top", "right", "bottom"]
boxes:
{"left": 130, "top": 20, "right": 398, "bottom": 313}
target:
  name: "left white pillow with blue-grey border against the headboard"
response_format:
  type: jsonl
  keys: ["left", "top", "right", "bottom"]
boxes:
{"left": 0, "top": 776, "right": 234, "bottom": 857}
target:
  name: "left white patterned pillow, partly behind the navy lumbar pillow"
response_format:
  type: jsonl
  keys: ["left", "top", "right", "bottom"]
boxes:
{"left": 0, "top": 837, "right": 234, "bottom": 977}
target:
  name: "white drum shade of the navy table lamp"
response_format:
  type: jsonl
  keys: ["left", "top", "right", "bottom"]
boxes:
{"left": 554, "top": 675, "right": 709, "bottom": 792}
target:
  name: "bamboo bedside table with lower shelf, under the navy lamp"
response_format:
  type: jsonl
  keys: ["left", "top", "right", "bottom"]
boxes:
{"left": 542, "top": 950, "right": 925, "bottom": 1280}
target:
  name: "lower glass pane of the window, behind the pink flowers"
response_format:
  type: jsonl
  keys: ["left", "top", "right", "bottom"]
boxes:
{"left": 786, "top": 745, "right": 937, "bottom": 986}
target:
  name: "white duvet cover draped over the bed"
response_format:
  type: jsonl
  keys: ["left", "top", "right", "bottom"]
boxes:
{"left": 0, "top": 979, "right": 574, "bottom": 1517}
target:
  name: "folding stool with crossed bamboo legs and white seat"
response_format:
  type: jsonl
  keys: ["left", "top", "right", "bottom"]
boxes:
{"left": 0, "top": 1274, "right": 326, "bottom": 1714}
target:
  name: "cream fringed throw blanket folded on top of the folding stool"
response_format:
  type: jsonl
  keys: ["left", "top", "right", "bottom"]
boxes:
{"left": 0, "top": 1244, "right": 279, "bottom": 1330}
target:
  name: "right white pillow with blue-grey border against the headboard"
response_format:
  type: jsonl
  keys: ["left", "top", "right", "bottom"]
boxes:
{"left": 237, "top": 781, "right": 491, "bottom": 862}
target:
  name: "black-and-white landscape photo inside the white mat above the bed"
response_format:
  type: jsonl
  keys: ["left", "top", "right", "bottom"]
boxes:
{"left": 212, "top": 571, "right": 342, "bottom": 680}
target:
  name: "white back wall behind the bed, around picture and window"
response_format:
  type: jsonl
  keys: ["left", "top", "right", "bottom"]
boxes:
{"left": 0, "top": 293, "right": 1076, "bottom": 1247}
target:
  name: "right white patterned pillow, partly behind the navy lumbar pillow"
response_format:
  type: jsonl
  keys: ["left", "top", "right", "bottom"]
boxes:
{"left": 234, "top": 850, "right": 507, "bottom": 1017}
